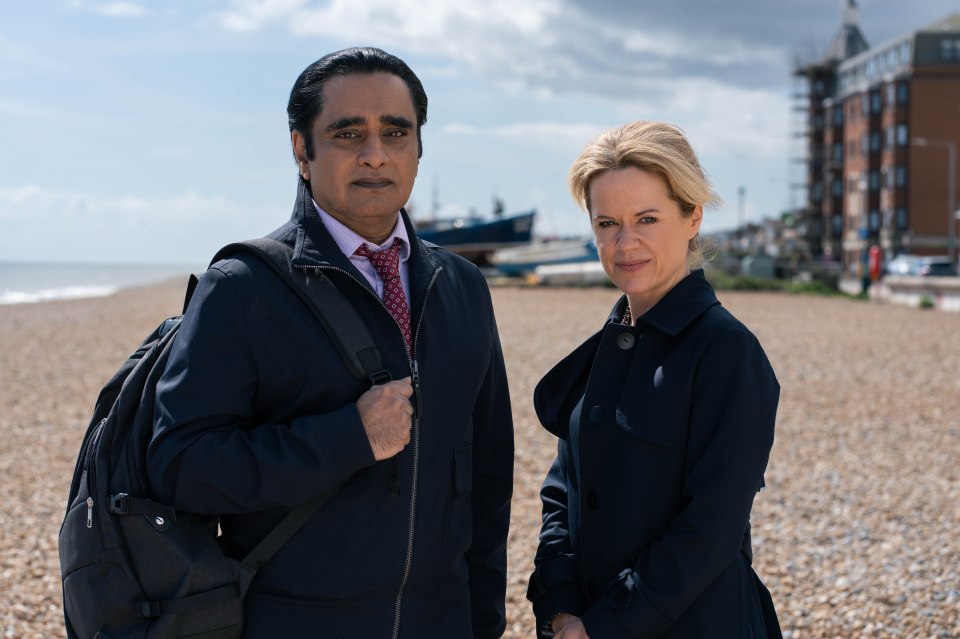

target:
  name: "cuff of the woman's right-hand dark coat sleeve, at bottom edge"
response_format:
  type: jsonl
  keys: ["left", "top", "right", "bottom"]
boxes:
{"left": 582, "top": 569, "right": 674, "bottom": 639}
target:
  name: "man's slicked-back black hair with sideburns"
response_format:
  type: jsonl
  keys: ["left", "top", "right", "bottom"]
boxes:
{"left": 287, "top": 47, "right": 427, "bottom": 160}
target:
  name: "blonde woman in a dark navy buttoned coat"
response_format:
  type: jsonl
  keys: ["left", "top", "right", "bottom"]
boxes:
{"left": 527, "top": 122, "right": 780, "bottom": 639}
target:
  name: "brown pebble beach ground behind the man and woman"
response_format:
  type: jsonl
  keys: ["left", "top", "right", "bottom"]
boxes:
{"left": 0, "top": 282, "right": 960, "bottom": 639}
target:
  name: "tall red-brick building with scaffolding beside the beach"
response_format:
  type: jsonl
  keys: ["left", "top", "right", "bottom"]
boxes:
{"left": 793, "top": 0, "right": 960, "bottom": 275}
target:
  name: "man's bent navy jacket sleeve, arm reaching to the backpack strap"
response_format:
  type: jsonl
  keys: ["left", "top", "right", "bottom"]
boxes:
{"left": 147, "top": 268, "right": 375, "bottom": 514}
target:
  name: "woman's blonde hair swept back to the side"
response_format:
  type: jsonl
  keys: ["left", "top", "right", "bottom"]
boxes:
{"left": 568, "top": 120, "right": 722, "bottom": 268}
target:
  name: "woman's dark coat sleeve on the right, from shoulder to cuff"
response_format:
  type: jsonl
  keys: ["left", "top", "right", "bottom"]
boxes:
{"left": 583, "top": 328, "right": 780, "bottom": 639}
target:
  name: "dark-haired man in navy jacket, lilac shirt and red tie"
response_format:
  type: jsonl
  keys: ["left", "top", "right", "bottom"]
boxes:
{"left": 148, "top": 49, "right": 513, "bottom": 639}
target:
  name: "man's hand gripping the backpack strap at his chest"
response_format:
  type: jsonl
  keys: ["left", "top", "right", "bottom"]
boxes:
{"left": 357, "top": 377, "right": 413, "bottom": 461}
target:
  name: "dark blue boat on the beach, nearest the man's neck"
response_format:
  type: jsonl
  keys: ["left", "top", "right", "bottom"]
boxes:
{"left": 414, "top": 210, "right": 536, "bottom": 265}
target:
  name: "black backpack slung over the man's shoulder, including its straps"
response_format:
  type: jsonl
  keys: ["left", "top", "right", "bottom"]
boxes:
{"left": 59, "top": 239, "right": 390, "bottom": 639}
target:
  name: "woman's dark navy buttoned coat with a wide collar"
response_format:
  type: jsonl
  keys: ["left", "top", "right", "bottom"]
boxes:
{"left": 528, "top": 271, "right": 780, "bottom": 639}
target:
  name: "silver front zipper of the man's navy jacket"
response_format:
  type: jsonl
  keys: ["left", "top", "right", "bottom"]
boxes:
{"left": 296, "top": 265, "right": 443, "bottom": 639}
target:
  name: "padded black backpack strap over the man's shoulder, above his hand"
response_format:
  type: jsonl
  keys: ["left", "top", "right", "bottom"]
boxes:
{"left": 210, "top": 238, "right": 391, "bottom": 384}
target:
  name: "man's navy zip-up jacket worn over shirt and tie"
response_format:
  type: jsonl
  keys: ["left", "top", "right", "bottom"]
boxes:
{"left": 148, "top": 183, "right": 513, "bottom": 639}
